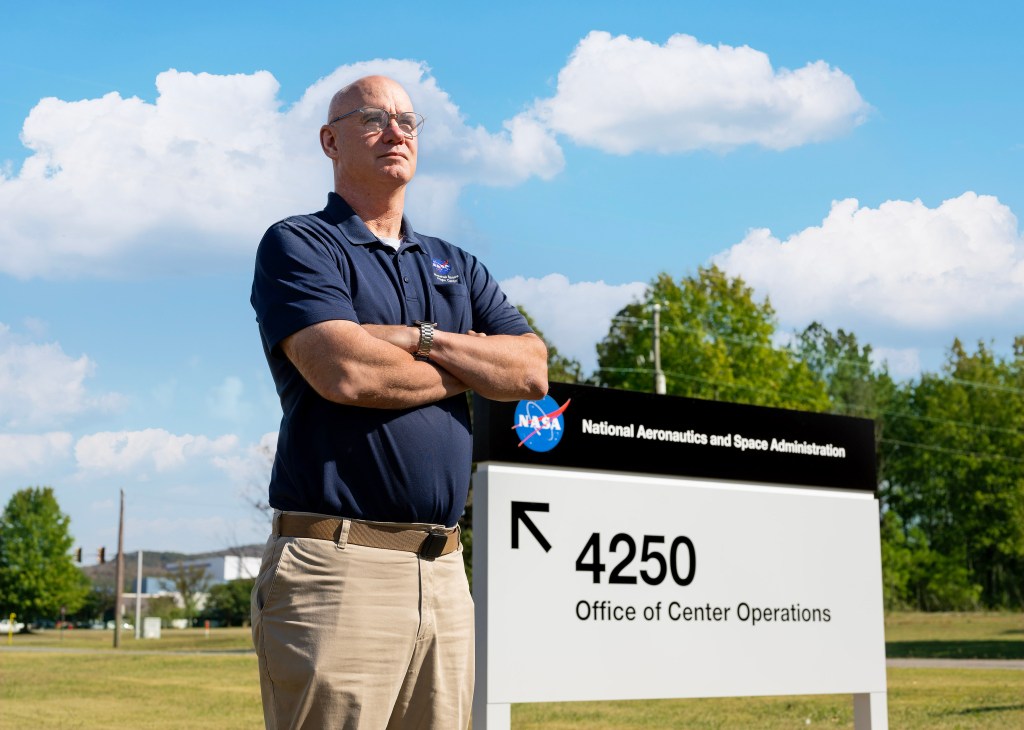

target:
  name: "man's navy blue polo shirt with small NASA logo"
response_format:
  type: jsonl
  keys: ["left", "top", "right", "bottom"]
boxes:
{"left": 251, "top": 192, "right": 530, "bottom": 525}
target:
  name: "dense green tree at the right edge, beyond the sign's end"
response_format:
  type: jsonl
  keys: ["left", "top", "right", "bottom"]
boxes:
{"left": 882, "top": 338, "right": 1024, "bottom": 608}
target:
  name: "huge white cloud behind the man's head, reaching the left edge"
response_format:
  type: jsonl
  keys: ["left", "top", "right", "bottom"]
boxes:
{"left": 0, "top": 59, "right": 563, "bottom": 277}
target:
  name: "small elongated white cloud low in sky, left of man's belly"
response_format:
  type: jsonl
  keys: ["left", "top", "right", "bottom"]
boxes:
{"left": 75, "top": 428, "right": 238, "bottom": 474}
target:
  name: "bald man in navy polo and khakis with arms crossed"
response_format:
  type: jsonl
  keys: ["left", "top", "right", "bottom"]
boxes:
{"left": 252, "top": 76, "right": 547, "bottom": 730}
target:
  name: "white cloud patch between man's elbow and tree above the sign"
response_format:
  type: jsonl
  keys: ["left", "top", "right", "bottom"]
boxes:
{"left": 501, "top": 273, "right": 647, "bottom": 372}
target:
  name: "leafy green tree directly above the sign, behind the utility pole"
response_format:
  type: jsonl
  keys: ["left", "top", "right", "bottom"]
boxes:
{"left": 597, "top": 266, "right": 828, "bottom": 411}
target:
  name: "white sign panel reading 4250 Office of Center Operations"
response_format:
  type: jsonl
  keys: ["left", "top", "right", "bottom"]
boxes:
{"left": 474, "top": 464, "right": 886, "bottom": 703}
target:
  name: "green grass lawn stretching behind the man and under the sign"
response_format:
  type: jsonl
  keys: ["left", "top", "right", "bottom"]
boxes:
{"left": 0, "top": 613, "right": 1024, "bottom": 730}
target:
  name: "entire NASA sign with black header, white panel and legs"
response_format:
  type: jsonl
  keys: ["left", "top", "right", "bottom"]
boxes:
{"left": 473, "top": 384, "right": 887, "bottom": 730}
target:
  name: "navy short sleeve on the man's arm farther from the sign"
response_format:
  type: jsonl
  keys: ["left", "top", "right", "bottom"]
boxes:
{"left": 250, "top": 218, "right": 358, "bottom": 350}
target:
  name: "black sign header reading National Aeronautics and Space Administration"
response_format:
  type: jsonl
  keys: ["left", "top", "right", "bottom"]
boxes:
{"left": 473, "top": 383, "right": 877, "bottom": 491}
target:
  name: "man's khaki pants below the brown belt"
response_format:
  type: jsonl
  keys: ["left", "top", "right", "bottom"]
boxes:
{"left": 252, "top": 518, "right": 473, "bottom": 730}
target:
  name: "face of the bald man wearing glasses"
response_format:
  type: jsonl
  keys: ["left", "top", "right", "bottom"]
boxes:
{"left": 321, "top": 78, "right": 417, "bottom": 186}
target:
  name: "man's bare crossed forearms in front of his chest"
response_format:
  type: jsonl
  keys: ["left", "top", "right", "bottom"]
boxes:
{"left": 282, "top": 319, "right": 548, "bottom": 409}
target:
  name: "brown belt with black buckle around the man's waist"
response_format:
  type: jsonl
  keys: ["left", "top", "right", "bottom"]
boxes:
{"left": 273, "top": 512, "right": 460, "bottom": 558}
